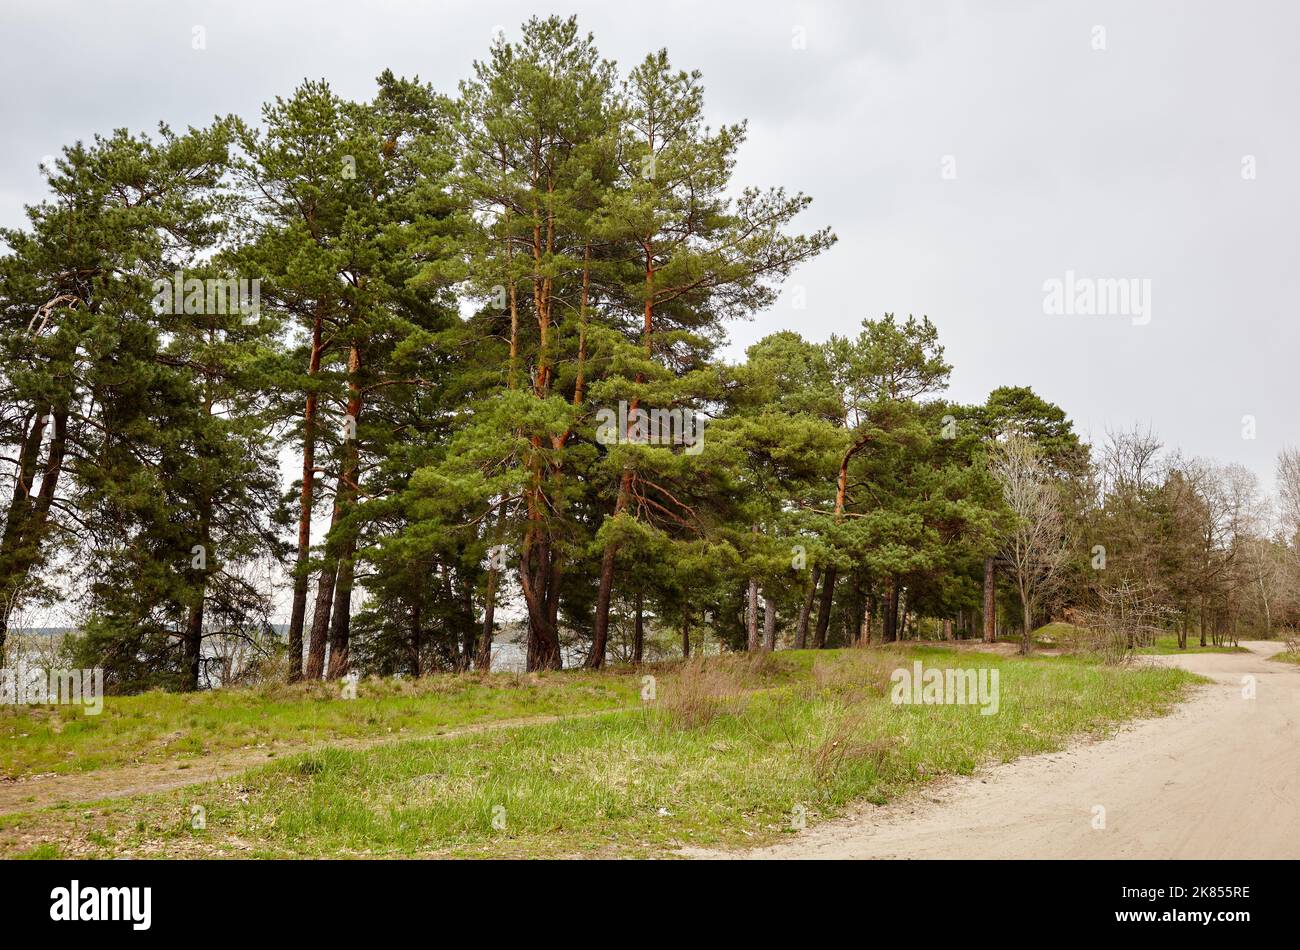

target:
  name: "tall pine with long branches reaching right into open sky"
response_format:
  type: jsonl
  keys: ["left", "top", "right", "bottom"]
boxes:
{"left": 588, "top": 51, "right": 833, "bottom": 667}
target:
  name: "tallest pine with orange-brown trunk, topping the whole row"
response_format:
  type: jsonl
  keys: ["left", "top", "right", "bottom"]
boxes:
{"left": 462, "top": 17, "right": 614, "bottom": 669}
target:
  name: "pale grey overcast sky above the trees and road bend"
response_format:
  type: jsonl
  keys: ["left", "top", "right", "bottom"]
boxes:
{"left": 0, "top": 0, "right": 1300, "bottom": 483}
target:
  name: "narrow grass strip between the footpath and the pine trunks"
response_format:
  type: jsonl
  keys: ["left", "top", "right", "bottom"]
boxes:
{"left": 0, "top": 672, "right": 640, "bottom": 778}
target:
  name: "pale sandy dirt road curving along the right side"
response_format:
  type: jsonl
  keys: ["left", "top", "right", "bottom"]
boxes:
{"left": 693, "top": 642, "right": 1300, "bottom": 859}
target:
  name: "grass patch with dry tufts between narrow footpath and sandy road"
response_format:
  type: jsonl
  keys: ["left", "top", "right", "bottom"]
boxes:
{"left": 0, "top": 647, "right": 1195, "bottom": 858}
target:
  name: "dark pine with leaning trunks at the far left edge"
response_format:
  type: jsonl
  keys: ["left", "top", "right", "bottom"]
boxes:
{"left": 0, "top": 125, "right": 226, "bottom": 675}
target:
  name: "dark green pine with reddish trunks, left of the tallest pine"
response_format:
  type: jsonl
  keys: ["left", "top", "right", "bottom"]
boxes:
{"left": 243, "top": 73, "right": 459, "bottom": 678}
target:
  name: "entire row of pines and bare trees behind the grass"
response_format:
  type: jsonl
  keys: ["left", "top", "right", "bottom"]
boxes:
{"left": 0, "top": 18, "right": 1300, "bottom": 690}
